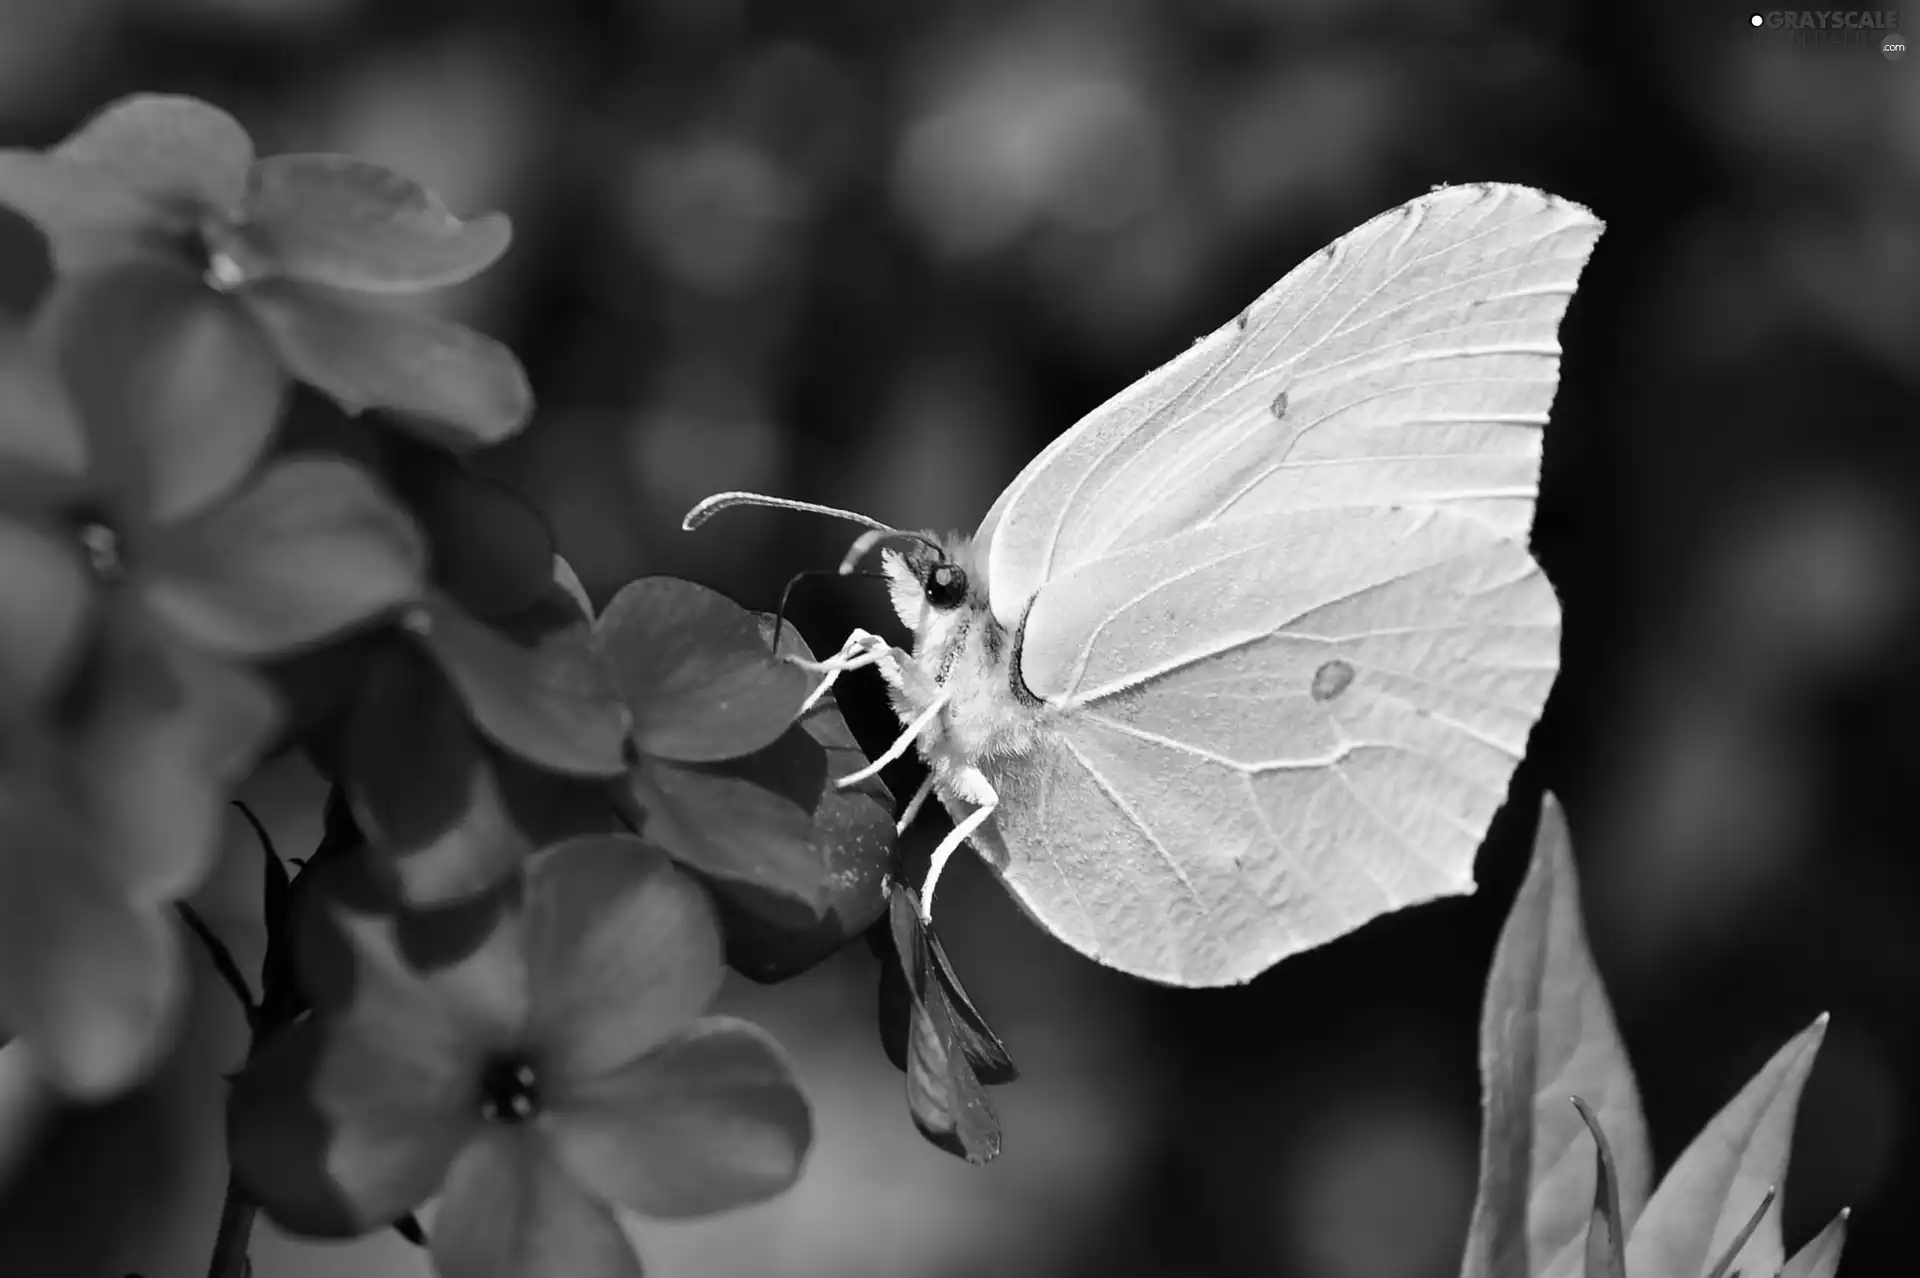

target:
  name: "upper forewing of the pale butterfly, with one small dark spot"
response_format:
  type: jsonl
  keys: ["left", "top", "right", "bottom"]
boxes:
{"left": 975, "top": 184, "right": 1601, "bottom": 626}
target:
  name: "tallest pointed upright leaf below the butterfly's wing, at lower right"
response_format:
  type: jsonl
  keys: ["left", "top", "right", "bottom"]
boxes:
{"left": 1461, "top": 794, "right": 1651, "bottom": 1278}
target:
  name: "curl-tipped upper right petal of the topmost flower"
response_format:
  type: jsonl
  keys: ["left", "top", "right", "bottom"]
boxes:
{"left": 244, "top": 155, "right": 513, "bottom": 292}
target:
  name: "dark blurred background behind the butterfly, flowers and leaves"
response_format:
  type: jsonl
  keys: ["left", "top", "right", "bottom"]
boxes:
{"left": 0, "top": 0, "right": 1920, "bottom": 1278}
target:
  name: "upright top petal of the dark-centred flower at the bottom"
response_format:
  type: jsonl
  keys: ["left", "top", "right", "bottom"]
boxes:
{"left": 526, "top": 835, "right": 726, "bottom": 1078}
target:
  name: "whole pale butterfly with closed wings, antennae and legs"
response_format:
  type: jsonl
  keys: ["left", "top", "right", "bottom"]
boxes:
{"left": 684, "top": 184, "right": 1601, "bottom": 986}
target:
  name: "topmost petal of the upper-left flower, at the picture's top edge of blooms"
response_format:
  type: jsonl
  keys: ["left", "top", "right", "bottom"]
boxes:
{"left": 52, "top": 94, "right": 253, "bottom": 211}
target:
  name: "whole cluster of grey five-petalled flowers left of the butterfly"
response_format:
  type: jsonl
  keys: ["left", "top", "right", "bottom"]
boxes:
{"left": 0, "top": 96, "right": 893, "bottom": 1276}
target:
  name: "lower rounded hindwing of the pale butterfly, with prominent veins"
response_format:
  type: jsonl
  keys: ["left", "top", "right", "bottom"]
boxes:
{"left": 983, "top": 509, "right": 1559, "bottom": 986}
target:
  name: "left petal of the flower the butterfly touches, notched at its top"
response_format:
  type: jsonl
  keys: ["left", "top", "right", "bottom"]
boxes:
{"left": 407, "top": 593, "right": 628, "bottom": 777}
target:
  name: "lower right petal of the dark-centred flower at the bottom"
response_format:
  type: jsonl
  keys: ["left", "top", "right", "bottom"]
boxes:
{"left": 549, "top": 1017, "right": 814, "bottom": 1219}
